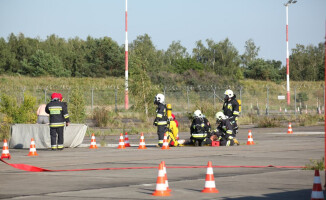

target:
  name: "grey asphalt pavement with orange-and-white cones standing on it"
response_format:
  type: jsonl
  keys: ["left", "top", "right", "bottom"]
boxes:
{"left": 0, "top": 126, "right": 325, "bottom": 200}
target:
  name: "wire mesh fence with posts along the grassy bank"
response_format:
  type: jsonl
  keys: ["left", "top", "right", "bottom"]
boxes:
{"left": 5, "top": 84, "right": 325, "bottom": 115}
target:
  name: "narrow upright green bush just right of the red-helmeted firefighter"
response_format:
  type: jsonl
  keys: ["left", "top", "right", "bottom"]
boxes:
{"left": 68, "top": 87, "right": 86, "bottom": 123}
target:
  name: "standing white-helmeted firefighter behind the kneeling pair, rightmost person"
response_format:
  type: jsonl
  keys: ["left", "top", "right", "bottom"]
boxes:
{"left": 223, "top": 90, "right": 239, "bottom": 132}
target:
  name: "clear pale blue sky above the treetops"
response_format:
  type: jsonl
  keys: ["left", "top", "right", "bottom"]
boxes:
{"left": 0, "top": 0, "right": 326, "bottom": 65}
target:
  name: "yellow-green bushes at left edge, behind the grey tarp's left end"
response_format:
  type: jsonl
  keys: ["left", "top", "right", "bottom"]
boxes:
{"left": 0, "top": 94, "right": 37, "bottom": 124}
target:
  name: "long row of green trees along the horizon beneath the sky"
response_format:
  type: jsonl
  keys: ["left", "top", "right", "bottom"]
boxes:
{"left": 0, "top": 34, "right": 324, "bottom": 85}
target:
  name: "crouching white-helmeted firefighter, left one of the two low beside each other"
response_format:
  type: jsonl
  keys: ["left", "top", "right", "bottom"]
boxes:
{"left": 190, "top": 110, "right": 211, "bottom": 146}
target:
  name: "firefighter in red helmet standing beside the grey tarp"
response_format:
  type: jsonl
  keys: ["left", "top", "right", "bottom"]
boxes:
{"left": 45, "top": 93, "right": 69, "bottom": 150}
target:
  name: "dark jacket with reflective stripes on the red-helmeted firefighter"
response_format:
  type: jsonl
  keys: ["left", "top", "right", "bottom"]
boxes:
{"left": 45, "top": 100, "right": 69, "bottom": 128}
